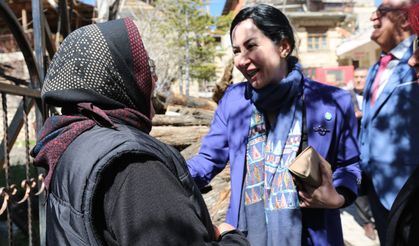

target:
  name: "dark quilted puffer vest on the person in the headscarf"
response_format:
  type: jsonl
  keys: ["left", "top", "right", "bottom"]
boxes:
{"left": 47, "top": 125, "right": 247, "bottom": 245}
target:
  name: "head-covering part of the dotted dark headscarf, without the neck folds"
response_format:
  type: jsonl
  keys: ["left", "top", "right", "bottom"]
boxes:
{"left": 41, "top": 19, "right": 152, "bottom": 121}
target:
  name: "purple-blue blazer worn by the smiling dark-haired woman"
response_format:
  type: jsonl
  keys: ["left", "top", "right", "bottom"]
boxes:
{"left": 187, "top": 79, "right": 361, "bottom": 245}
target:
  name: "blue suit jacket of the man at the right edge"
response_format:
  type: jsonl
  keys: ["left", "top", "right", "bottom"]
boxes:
{"left": 359, "top": 40, "right": 419, "bottom": 210}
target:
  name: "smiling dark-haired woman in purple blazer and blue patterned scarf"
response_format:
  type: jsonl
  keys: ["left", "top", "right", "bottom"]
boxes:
{"left": 188, "top": 4, "right": 360, "bottom": 246}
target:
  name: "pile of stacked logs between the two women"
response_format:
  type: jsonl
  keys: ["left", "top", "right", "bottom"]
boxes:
{"left": 150, "top": 95, "right": 230, "bottom": 224}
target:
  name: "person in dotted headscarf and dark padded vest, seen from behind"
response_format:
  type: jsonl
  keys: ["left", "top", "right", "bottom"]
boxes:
{"left": 32, "top": 19, "right": 247, "bottom": 245}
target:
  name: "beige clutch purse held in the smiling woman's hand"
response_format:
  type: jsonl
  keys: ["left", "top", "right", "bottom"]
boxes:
{"left": 288, "top": 146, "right": 330, "bottom": 188}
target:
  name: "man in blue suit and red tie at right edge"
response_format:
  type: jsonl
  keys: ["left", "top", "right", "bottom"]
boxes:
{"left": 360, "top": 0, "right": 419, "bottom": 243}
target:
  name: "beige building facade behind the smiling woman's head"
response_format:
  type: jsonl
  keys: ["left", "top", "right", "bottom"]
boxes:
{"left": 223, "top": 0, "right": 375, "bottom": 86}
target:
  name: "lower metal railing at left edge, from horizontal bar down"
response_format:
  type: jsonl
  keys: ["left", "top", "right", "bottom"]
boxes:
{"left": 0, "top": 82, "right": 45, "bottom": 245}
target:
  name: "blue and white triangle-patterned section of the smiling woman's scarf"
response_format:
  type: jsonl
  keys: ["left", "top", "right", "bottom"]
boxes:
{"left": 244, "top": 108, "right": 301, "bottom": 210}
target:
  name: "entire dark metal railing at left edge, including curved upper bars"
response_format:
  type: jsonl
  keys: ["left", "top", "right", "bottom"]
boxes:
{"left": 0, "top": 0, "right": 47, "bottom": 245}
